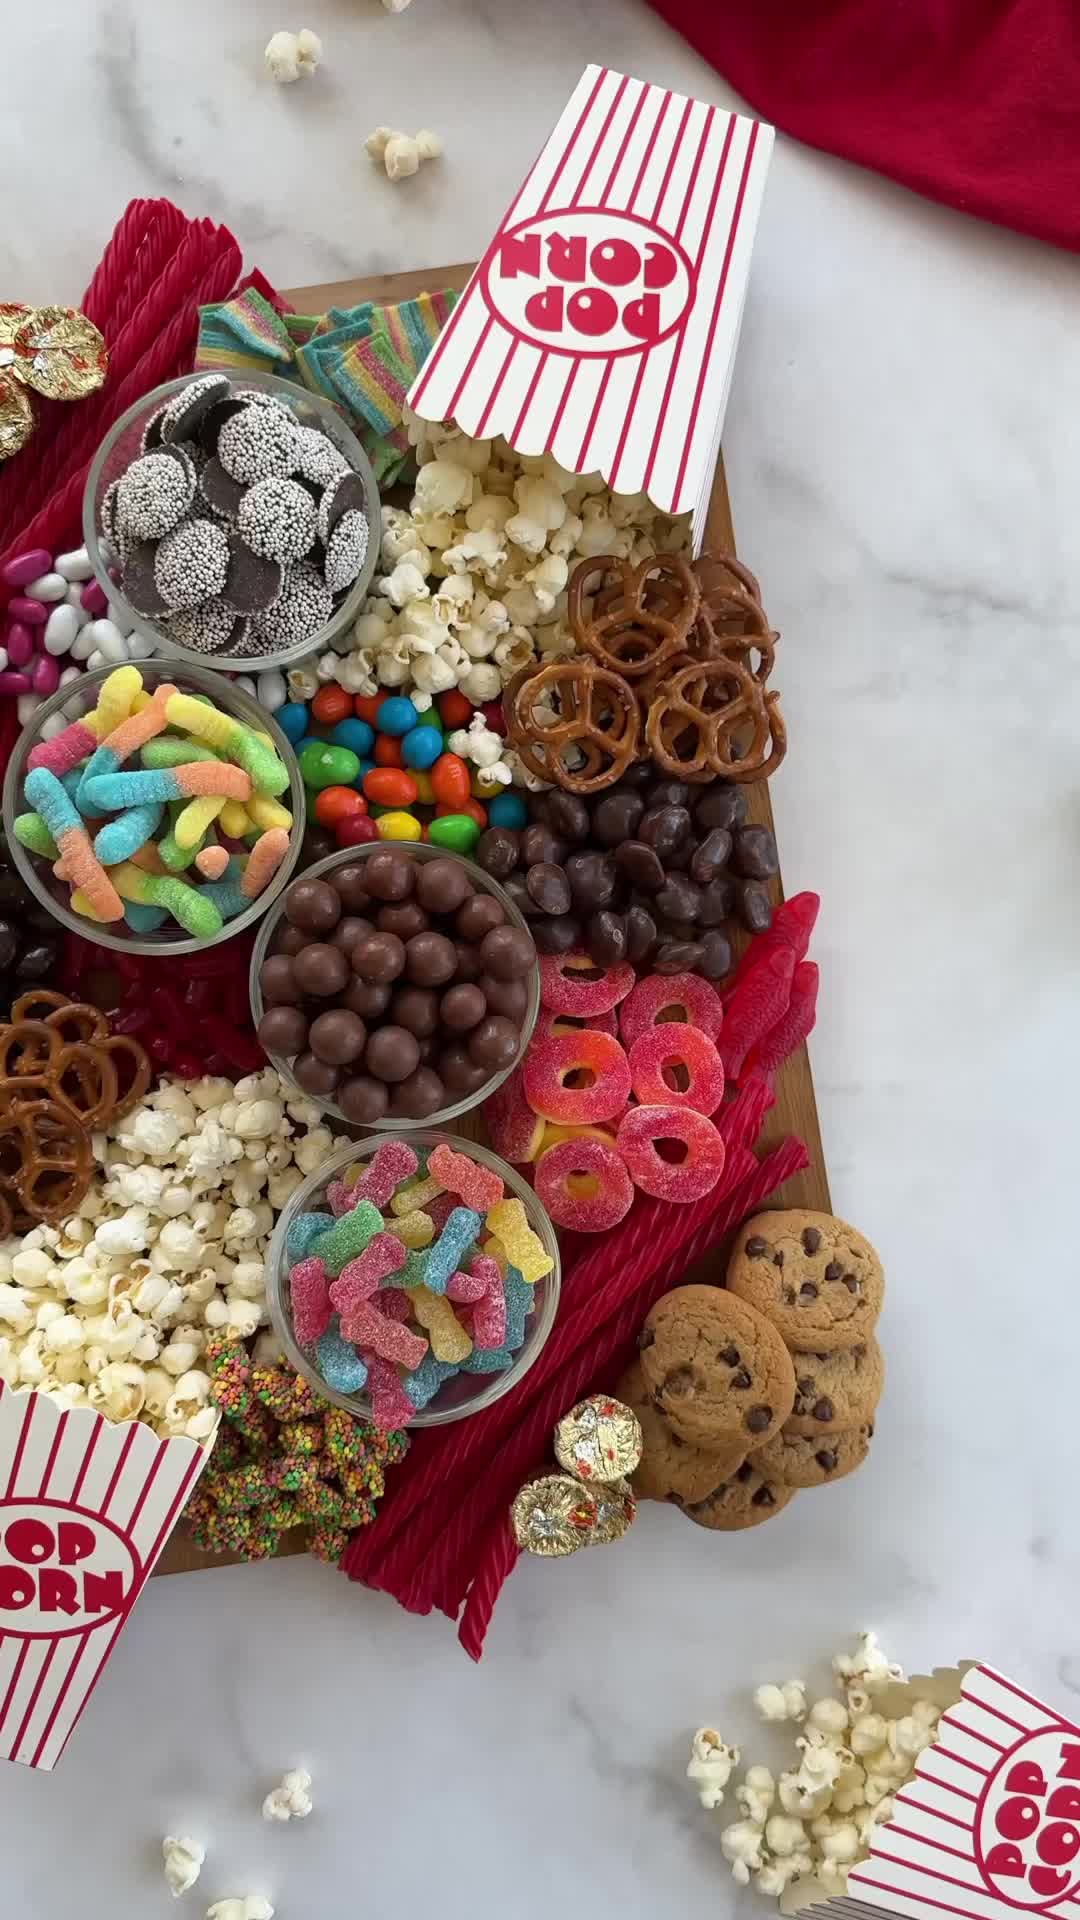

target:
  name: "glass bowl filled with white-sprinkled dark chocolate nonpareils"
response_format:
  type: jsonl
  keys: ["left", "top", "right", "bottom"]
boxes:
{"left": 83, "top": 372, "right": 380, "bottom": 672}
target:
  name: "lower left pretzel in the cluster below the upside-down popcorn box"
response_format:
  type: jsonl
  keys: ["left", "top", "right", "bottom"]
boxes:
{"left": 505, "top": 659, "right": 640, "bottom": 793}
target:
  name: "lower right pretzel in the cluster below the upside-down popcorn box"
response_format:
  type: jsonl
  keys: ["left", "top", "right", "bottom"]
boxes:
{"left": 646, "top": 659, "right": 788, "bottom": 781}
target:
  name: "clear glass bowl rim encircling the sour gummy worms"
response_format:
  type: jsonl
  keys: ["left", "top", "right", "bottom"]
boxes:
{"left": 4, "top": 660, "right": 304, "bottom": 954}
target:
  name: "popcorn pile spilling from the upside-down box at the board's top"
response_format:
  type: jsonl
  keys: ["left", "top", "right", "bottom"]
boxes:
{"left": 313, "top": 424, "right": 690, "bottom": 721}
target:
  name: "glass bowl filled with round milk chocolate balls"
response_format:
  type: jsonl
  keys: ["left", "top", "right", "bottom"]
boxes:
{"left": 250, "top": 841, "right": 540, "bottom": 1131}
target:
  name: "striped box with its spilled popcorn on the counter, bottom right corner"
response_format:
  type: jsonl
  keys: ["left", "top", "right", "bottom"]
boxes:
{"left": 686, "top": 1634, "right": 1080, "bottom": 1920}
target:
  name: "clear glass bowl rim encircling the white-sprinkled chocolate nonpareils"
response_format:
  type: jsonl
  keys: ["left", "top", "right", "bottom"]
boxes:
{"left": 83, "top": 367, "right": 382, "bottom": 674}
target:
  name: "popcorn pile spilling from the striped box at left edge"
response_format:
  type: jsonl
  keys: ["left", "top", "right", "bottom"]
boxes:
{"left": 0, "top": 1068, "right": 315, "bottom": 1442}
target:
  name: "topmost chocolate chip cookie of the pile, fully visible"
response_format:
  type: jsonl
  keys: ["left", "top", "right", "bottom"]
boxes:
{"left": 728, "top": 1208, "right": 884, "bottom": 1354}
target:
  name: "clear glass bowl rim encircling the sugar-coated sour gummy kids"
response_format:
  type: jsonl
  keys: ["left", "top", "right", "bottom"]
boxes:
{"left": 267, "top": 1129, "right": 561, "bottom": 1428}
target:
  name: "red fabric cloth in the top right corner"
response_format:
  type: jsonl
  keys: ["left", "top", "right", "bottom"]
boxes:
{"left": 650, "top": 0, "right": 1080, "bottom": 250}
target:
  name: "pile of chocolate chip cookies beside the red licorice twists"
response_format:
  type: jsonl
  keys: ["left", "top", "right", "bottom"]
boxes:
{"left": 617, "top": 1210, "right": 884, "bottom": 1532}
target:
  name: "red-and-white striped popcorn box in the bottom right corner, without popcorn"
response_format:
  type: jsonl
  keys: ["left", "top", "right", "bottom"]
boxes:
{"left": 799, "top": 1665, "right": 1080, "bottom": 1920}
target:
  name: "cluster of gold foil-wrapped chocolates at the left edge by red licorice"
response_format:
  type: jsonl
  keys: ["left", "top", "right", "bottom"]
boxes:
{"left": 0, "top": 301, "right": 110, "bottom": 461}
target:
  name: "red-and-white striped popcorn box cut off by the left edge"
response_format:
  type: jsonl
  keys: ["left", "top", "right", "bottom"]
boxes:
{"left": 0, "top": 1386, "right": 211, "bottom": 1772}
